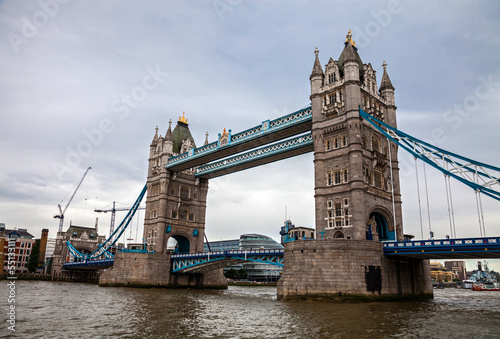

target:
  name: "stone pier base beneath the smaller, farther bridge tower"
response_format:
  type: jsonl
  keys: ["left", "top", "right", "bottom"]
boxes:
{"left": 99, "top": 253, "right": 227, "bottom": 288}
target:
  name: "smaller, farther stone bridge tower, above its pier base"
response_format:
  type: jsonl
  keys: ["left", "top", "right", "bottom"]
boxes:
{"left": 144, "top": 115, "right": 208, "bottom": 253}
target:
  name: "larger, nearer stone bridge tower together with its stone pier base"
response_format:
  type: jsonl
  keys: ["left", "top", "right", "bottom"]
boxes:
{"left": 278, "top": 31, "right": 432, "bottom": 301}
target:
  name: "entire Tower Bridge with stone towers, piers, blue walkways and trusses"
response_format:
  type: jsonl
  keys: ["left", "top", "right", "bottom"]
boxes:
{"left": 62, "top": 31, "right": 500, "bottom": 300}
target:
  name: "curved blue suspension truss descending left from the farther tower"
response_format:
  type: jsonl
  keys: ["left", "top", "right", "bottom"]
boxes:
{"left": 66, "top": 185, "right": 147, "bottom": 261}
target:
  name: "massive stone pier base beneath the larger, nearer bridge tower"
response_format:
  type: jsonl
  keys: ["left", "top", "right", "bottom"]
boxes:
{"left": 278, "top": 239, "right": 433, "bottom": 301}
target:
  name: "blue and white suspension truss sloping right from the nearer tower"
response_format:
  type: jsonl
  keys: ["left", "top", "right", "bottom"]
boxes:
{"left": 359, "top": 108, "right": 500, "bottom": 201}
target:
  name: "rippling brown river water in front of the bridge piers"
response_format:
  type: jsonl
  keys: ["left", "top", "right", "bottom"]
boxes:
{"left": 0, "top": 280, "right": 500, "bottom": 339}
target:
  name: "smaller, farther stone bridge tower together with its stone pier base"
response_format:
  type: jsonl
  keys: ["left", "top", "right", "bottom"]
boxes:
{"left": 99, "top": 114, "right": 227, "bottom": 288}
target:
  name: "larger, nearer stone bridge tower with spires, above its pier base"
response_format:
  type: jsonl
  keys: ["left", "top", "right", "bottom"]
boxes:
{"left": 310, "top": 31, "right": 403, "bottom": 240}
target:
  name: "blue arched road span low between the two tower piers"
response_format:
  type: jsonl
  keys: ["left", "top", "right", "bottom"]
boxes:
{"left": 171, "top": 249, "right": 284, "bottom": 273}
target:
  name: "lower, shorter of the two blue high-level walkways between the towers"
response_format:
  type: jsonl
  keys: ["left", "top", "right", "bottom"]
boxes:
{"left": 195, "top": 133, "right": 314, "bottom": 179}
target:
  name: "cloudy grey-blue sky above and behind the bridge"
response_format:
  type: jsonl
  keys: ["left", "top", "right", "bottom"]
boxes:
{"left": 0, "top": 0, "right": 500, "bottom": 268}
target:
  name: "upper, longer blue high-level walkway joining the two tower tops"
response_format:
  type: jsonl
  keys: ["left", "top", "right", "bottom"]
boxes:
{"left": 165, "top": 106, "right": 312, "bottom": 172}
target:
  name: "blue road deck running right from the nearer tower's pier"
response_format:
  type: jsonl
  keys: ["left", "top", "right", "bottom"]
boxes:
{"left": 384, "top": 237, "right": 500, "bottom": 259}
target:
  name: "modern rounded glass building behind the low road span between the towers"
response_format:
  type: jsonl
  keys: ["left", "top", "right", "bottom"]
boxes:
{"left": 203, "top": 234, "right": 283, "bottom": 282}
